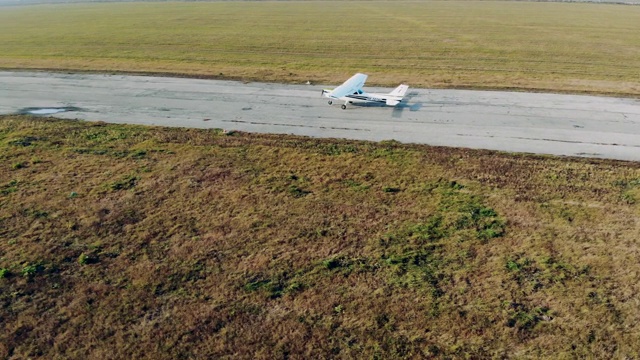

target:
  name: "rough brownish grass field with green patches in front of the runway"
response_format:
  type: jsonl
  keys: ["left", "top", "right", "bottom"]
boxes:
{"left": 0, "top": 116, "right": 640, "bottom": 359}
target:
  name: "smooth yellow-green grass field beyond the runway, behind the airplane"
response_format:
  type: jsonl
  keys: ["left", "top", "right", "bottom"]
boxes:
{"left": 0, "top": 1, "right": 640, "bottom": 96}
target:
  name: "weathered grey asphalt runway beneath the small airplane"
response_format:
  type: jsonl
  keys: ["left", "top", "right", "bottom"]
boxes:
{"left": 0, "top": 72, "right": 640, "bottom": 161}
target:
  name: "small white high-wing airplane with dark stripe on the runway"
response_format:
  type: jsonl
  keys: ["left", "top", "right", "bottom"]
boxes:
{"left": 322, "top": 73, "right": 409, "bottom": 110}
